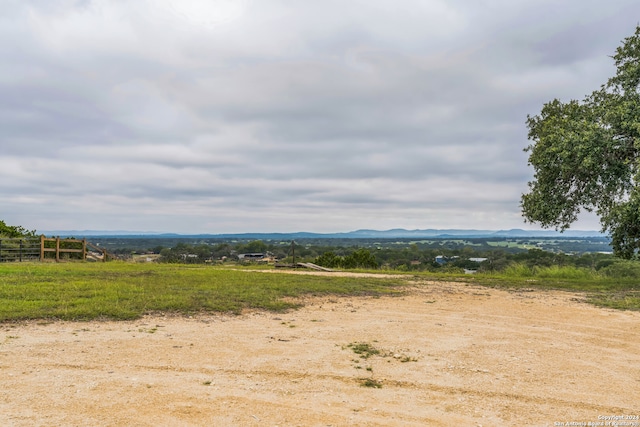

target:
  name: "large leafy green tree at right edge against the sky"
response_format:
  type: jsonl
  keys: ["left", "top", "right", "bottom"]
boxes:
{"left": 521, "top": 26, "right": 640, "bottom": 258}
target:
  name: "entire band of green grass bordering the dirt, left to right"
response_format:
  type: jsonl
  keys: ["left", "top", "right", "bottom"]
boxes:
{"left": 0, "top": 262, "right": 640, "bottom": 322}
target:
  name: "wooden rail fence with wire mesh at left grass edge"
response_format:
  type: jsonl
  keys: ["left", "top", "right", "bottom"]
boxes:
{"left": 0, "top": 236, "right": 115, "bottom": 262}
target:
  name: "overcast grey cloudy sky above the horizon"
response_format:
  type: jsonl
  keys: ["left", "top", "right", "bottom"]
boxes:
{"left": 0, "top": 0, "right": 640, "bottom": 234}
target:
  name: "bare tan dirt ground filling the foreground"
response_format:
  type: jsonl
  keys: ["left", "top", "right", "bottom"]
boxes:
{"left": 0, "top": 276, "right": 640, "bottom": 426}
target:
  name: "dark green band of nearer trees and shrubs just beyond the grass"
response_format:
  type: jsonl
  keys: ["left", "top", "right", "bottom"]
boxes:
{"left": 144, "top": 240, "right": 619, "bottom": 272}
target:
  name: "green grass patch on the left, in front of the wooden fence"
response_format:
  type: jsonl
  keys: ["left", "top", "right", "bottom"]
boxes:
{"left": 0, "top": 262, "right": 400, "bottom": 321}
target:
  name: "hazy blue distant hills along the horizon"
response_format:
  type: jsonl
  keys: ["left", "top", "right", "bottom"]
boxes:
{"left": 39, "top": 228, "right": 607, "bottom": 240}
